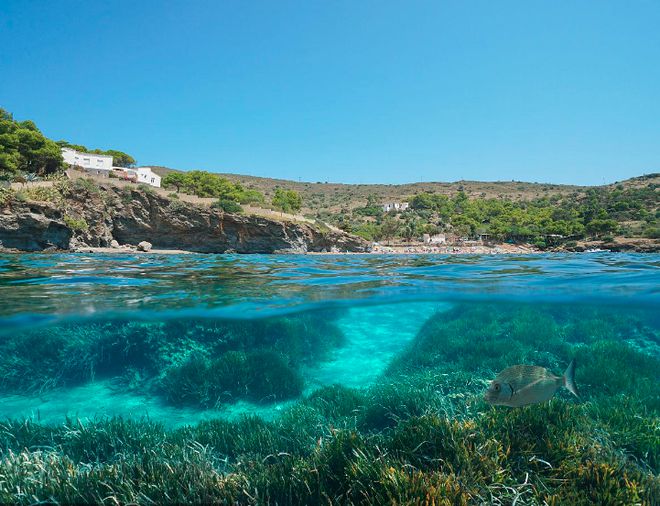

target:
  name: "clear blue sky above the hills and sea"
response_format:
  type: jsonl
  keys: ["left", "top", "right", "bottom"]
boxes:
{"left": 0, "top": 0, "right": 660, "bottom": 184}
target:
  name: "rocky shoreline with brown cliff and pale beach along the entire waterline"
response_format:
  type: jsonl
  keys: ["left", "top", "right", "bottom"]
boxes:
{"left": 0, "top": 179, "right": 660, "bottom": 255}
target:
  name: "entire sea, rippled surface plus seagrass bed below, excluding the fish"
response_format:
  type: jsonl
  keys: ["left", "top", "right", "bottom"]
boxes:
{"left": 0, "top": 253, "right": 660, "bottom": 505}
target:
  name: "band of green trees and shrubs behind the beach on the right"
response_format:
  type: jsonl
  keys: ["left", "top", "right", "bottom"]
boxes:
{"left": 326, "top": 182, "right": 660, "bottom": 248}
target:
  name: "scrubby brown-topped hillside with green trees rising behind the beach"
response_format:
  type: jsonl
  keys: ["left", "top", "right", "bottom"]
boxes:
{"left": 151, "top": 167, "right": 660, "bottom": 249}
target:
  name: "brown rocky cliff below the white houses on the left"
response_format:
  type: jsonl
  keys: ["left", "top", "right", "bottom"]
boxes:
{"left": 0, "top": 180, "right": 367, "bottom": 253}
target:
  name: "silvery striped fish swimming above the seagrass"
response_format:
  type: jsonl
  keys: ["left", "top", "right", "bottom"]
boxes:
{"left": 484, "top": 359, "right": 580, "bottom": 408}
